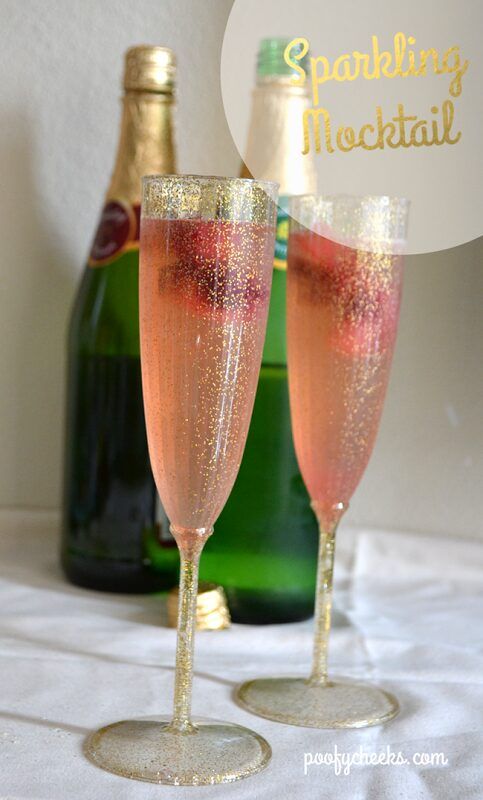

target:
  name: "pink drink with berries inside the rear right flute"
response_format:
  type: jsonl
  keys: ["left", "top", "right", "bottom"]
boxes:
{"left": 287, "top": 230, "right": 402, "bottom": 514}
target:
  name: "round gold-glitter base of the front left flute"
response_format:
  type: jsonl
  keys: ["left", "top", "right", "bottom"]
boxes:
{"left": 85, "top": 717, "right": 272, "bottom": 786}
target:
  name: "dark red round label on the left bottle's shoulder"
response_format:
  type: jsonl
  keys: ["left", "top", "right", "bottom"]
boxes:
{"left": 89, "top": 200, "right": 140, "bottom": 267}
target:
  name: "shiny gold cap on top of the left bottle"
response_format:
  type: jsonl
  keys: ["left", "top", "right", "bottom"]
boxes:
{"left": 123, "top": 45, "right": 176, "bottom": 94}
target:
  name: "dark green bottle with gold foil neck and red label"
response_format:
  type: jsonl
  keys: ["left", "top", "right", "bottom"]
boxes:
{"left": 62, "top": 46, "right": 178, "bottom": 592}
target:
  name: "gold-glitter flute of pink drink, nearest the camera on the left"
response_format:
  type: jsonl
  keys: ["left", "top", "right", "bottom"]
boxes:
{"left": 87, "top": 175, "right": 277, "bottom": 785}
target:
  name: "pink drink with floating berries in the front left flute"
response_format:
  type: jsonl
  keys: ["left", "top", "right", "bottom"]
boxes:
{"left": 140, "top": 218, "right": 273, "bottom": 528}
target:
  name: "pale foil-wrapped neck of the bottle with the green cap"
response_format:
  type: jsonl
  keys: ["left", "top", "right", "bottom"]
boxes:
{"left": 243, "top": 79, "right": 316, "bottom": 195}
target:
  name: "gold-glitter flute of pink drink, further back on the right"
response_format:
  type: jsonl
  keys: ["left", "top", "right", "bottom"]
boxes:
{"left": 238, "top": 195, "right": 408, "bottom": 728}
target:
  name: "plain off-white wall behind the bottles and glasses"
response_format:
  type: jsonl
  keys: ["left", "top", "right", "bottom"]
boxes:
{"left": 0, "top": 0, "right": 483, "bottom": 536}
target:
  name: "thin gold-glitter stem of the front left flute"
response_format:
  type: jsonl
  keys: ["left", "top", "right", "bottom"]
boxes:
{"left": 170, "top": 526, "right": 213, "bottom": 733}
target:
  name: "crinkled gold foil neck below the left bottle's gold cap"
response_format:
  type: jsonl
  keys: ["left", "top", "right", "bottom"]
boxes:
{"left": 106, "top": 91, "right": 176, "bottom": 205}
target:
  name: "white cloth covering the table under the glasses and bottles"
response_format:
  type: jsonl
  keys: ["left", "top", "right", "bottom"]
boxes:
{"left": 0, "top": 515, "right": 483, "bottom": 800}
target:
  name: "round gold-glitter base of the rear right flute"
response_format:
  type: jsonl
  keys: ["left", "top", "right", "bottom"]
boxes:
{"left": 237, "top": 678, "right": 399, "bottom": 728}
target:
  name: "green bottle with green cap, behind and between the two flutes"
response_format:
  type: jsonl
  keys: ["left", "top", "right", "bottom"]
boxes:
{"left": 201, "top": 39, "right": 318, "bottom": 623}
